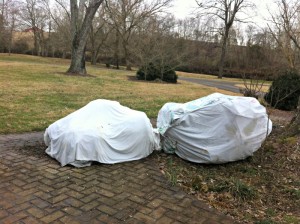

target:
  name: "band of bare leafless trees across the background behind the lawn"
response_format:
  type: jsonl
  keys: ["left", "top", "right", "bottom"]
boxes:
{"left": 0, "top": 0, "right": 300, "bottom": 78}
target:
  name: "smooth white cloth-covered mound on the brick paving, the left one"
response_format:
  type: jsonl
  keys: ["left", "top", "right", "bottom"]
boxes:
{"left": 44, "top": 99, "right": 160, "bottom": 167}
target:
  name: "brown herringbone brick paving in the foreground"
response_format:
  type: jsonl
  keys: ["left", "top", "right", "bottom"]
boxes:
{"left": 0, "top": 133, "right": 233, "bottom": 224}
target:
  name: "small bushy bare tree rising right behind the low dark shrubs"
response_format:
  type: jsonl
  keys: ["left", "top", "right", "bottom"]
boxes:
{"left": 133, "top": 16, "right": 187, "bottom": 80}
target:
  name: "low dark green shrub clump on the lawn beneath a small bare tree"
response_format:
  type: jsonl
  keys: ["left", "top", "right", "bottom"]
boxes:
{"left": 136, "top": 63, "right": 178, "bottom": 83}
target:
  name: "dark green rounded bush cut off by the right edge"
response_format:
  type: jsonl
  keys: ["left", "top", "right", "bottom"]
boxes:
{"left": 265, "top": 71, "right": 300, "bottom": 110}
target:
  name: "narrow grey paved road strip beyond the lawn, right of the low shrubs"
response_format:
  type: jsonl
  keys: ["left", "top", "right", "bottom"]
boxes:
{"left": 178, "top": 77, "right": 240, "bottom": 93}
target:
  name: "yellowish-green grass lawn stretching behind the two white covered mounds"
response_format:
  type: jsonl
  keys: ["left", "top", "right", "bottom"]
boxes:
{"left": 0, "top": 54, "right": 236, "bottom": 134}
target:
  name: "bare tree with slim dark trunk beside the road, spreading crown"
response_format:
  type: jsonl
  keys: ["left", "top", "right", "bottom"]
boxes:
{"left": 196, "top": 0, "right": 254, "bottom": 78}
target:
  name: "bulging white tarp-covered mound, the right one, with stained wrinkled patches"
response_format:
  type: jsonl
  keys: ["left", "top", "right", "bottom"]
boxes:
{"left": 157, "top": 93, "right": 272, "bottom": 163}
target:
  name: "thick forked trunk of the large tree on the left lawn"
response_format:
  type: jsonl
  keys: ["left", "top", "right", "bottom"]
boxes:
{"left": 67, "top": 0, "right": 103, "bottom": 75}
